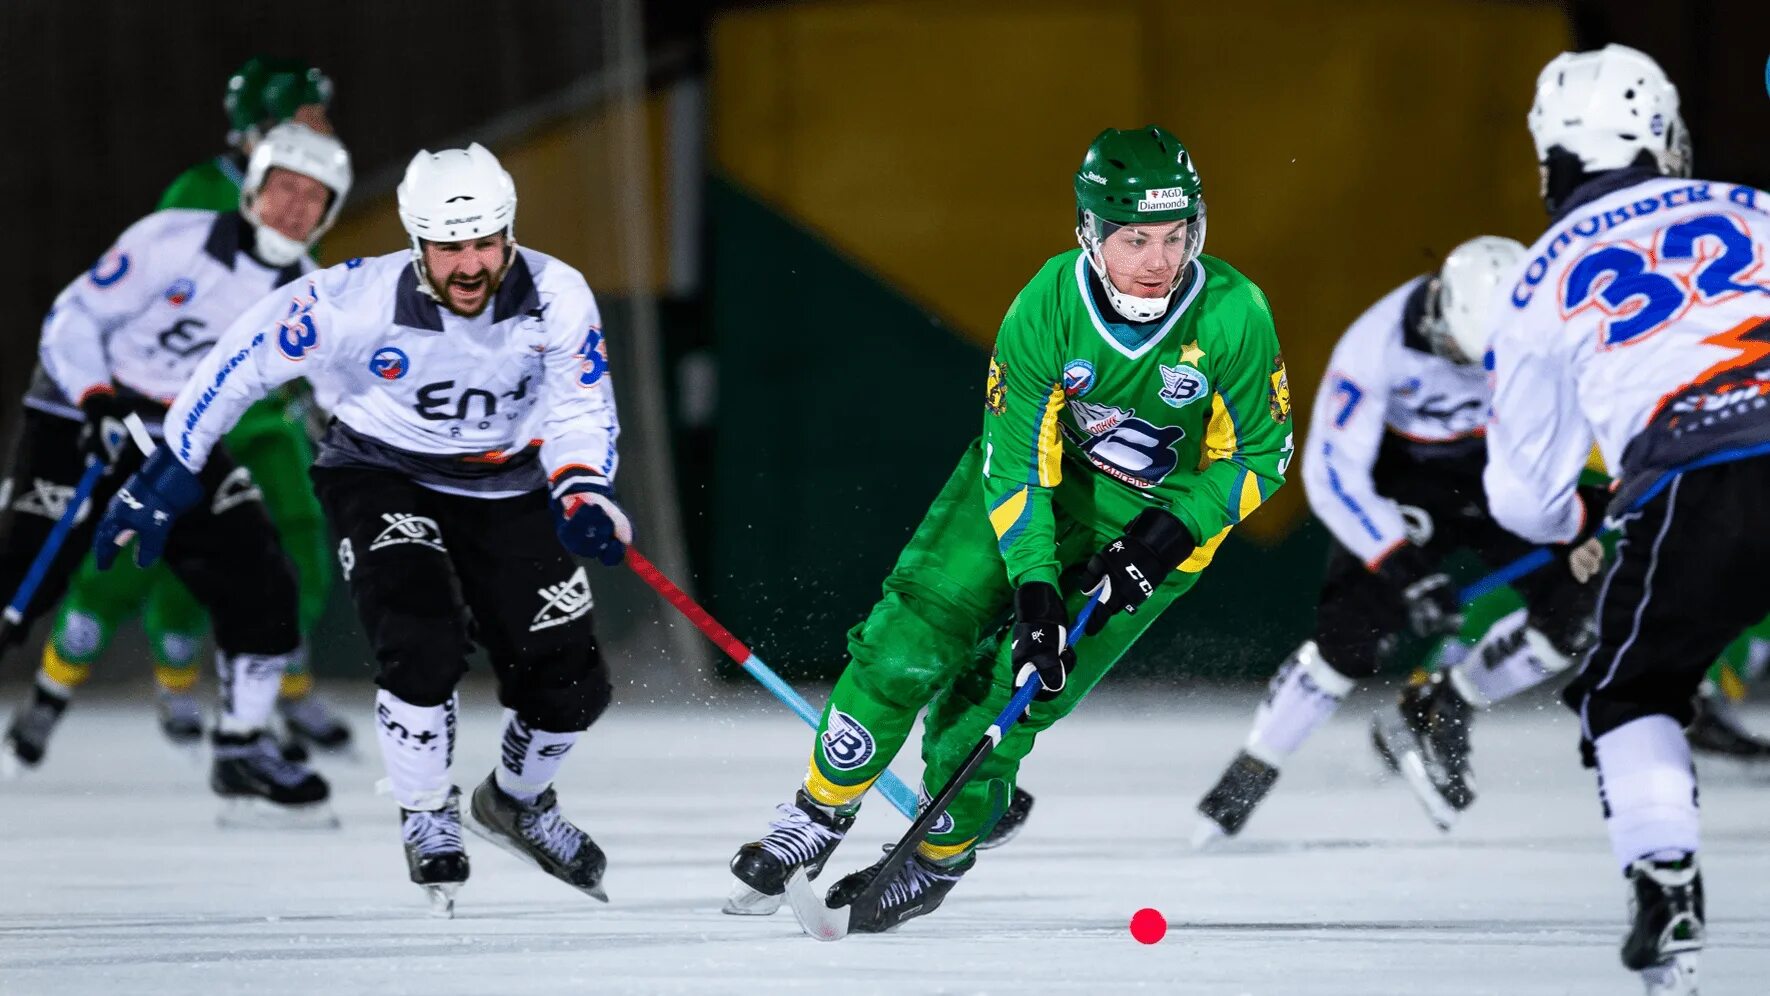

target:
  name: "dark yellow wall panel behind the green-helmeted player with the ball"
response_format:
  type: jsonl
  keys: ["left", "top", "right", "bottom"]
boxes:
{"left": 712, "top": 0, "right": 1570, "bottom": 534}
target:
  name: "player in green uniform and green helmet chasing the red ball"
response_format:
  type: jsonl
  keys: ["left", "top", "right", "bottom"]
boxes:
{"left": 726, "top": 127, "right": 1292, "bottom": 932}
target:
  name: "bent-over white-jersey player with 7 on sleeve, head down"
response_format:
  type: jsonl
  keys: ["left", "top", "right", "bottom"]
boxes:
{"left": 1193, "top": 235, "right": 1597, "bottom": 846}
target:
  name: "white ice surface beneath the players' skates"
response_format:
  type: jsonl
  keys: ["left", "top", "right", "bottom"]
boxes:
{"left": 0, "top": 685, "right": 1770, "bottom": 996}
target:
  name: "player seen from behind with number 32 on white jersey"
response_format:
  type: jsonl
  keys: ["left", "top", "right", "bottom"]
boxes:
{"left": 1485, "top": 44, "right": 1770, "bottom": 992}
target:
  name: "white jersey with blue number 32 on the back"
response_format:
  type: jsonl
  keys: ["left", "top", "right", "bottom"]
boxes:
{"left": 1485, "top": 170, "right": 1770, "bottom": 543}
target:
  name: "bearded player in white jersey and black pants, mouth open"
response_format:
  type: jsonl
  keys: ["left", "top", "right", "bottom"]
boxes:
{"left": 97, "top": 145, "right": 632, "bottom": 911}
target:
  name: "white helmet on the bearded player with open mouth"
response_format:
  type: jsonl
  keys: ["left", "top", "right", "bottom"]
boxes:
{"left": 398, "top": 142, "right": 517, "bottom": 297}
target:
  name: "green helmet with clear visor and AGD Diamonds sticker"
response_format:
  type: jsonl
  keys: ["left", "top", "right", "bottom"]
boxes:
{"left": 1076, "top": 124, "right": 1205, "bottom": 322}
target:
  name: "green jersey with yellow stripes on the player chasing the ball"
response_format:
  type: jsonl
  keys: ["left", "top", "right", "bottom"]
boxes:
{"left": 984, "top": 249, "right": 1292, "bottom": 586}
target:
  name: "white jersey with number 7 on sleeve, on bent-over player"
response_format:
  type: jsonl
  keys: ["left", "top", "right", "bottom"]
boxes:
{"left": 1303, "top": 276, "right": 1487, "bottom": 564}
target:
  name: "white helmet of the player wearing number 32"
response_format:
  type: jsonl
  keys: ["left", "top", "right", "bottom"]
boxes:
{"left": 1529, "top": 44, "right": 1690, "bottom": 177}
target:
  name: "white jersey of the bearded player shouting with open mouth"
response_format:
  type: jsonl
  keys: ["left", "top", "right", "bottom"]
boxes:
{"left": 166, "top": 248, "right": 620, "bottom": 497}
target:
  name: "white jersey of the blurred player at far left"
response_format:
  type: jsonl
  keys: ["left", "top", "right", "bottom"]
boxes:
{"left": 25, "top": 211, "right": 313, "bottom": 418}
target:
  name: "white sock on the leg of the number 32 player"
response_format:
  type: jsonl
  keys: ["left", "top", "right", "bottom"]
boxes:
{"left": 1593, "top": 715, "right": 1699, "bottom": 872}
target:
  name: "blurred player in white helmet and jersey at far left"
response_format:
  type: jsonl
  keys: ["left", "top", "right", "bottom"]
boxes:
{"left": 0, "top": 124, "right": 350, "bottom": 823}
